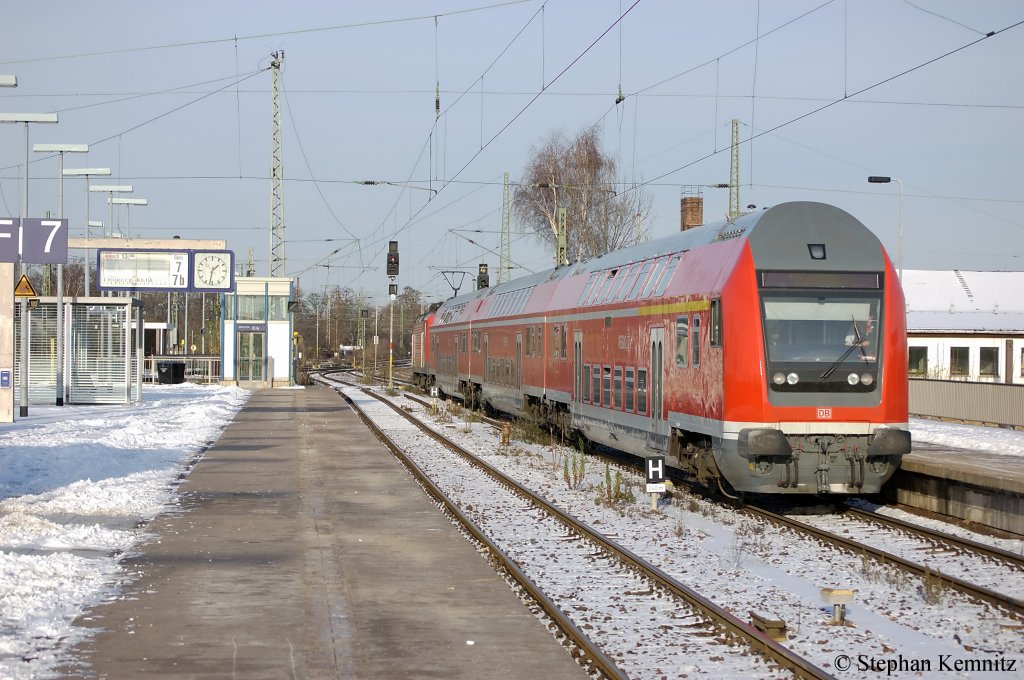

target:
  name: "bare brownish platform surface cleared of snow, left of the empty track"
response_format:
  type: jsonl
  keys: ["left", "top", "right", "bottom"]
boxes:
{"left": 62, "top": 386, "right": 586, "bottom": 679}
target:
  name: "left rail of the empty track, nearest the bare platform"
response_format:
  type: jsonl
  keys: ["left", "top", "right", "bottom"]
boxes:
{"left": 339, "top": 385, "right": 628, "bottom": 680}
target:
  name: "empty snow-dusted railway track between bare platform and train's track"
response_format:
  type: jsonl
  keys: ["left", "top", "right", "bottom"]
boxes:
{"left": 333, "top": 378, "right": 831, "bottom": 678}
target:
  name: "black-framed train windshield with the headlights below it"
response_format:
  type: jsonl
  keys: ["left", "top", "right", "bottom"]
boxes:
{"left": 762, "top": 291, "right": 882, "bottom": 392}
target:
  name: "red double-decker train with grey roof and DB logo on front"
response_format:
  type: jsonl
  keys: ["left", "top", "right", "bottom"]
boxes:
{"left": 413, "top": 202, "right": 910, "bottom": 495}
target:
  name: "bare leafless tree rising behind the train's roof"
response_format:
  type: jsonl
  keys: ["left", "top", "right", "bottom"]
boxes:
{"left": 513, "top": 128, "right": 652, "bottom": 260}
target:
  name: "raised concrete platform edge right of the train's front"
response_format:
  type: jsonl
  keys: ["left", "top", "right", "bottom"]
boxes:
{"left": 883, "top": 447, "right": 1024, "bottom": 536}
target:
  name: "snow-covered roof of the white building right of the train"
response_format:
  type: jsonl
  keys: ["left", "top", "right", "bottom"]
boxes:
{"left": 903, "top": 269, "right": 1024, "bottom": 334}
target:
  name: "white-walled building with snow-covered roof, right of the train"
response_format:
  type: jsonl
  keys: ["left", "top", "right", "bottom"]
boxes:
{"left": 903, "top": 269, "right": 1024, "bottom": 384}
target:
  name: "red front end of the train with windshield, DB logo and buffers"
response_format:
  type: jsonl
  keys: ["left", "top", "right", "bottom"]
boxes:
{"left": 715, "top": 204, "right": 910, "bottom": 495}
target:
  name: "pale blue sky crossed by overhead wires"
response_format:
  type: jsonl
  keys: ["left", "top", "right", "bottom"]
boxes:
{"left": 0, "top": 0, "right": 1024, "bottom": 302}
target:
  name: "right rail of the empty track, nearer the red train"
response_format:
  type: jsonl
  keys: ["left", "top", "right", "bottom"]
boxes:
{"left": 350, "top": 389, "right": 835, "bottom": 680}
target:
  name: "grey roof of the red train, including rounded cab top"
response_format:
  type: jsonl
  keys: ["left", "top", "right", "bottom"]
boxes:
{"left": 442, "top": 201, "right": 884, "bottom": 321}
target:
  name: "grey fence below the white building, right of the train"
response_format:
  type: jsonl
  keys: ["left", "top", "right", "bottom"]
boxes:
{"left": 910, "top": 378, "right": 1024, "bottom": 429}
